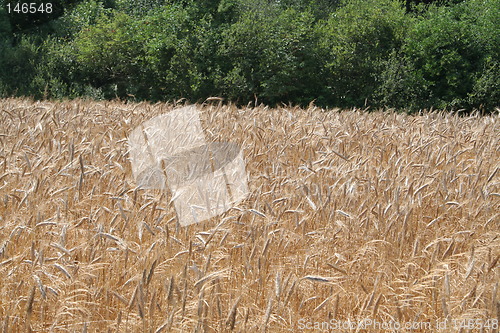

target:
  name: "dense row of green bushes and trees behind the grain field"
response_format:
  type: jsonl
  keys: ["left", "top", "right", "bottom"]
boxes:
{"left": 0, "top": 0, "right": 500, "bottom": 111}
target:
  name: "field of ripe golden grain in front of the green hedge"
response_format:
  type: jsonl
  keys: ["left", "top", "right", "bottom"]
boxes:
{"left": 0, "top": 99, "right": 500, "bottom": 332}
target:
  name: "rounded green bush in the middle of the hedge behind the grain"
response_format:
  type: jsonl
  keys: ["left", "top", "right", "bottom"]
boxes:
{"left": 217, "top": 8, "right": 320, "bottom": 103}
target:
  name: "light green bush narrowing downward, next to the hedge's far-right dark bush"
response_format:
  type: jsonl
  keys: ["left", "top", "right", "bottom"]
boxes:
{"left": 319, "top": 0, "right": 409, "bottom": 106}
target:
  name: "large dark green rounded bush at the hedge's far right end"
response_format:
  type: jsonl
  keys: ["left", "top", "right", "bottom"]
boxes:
{"left": 390, "top": 0, "right": 500, "bottom": 108}
